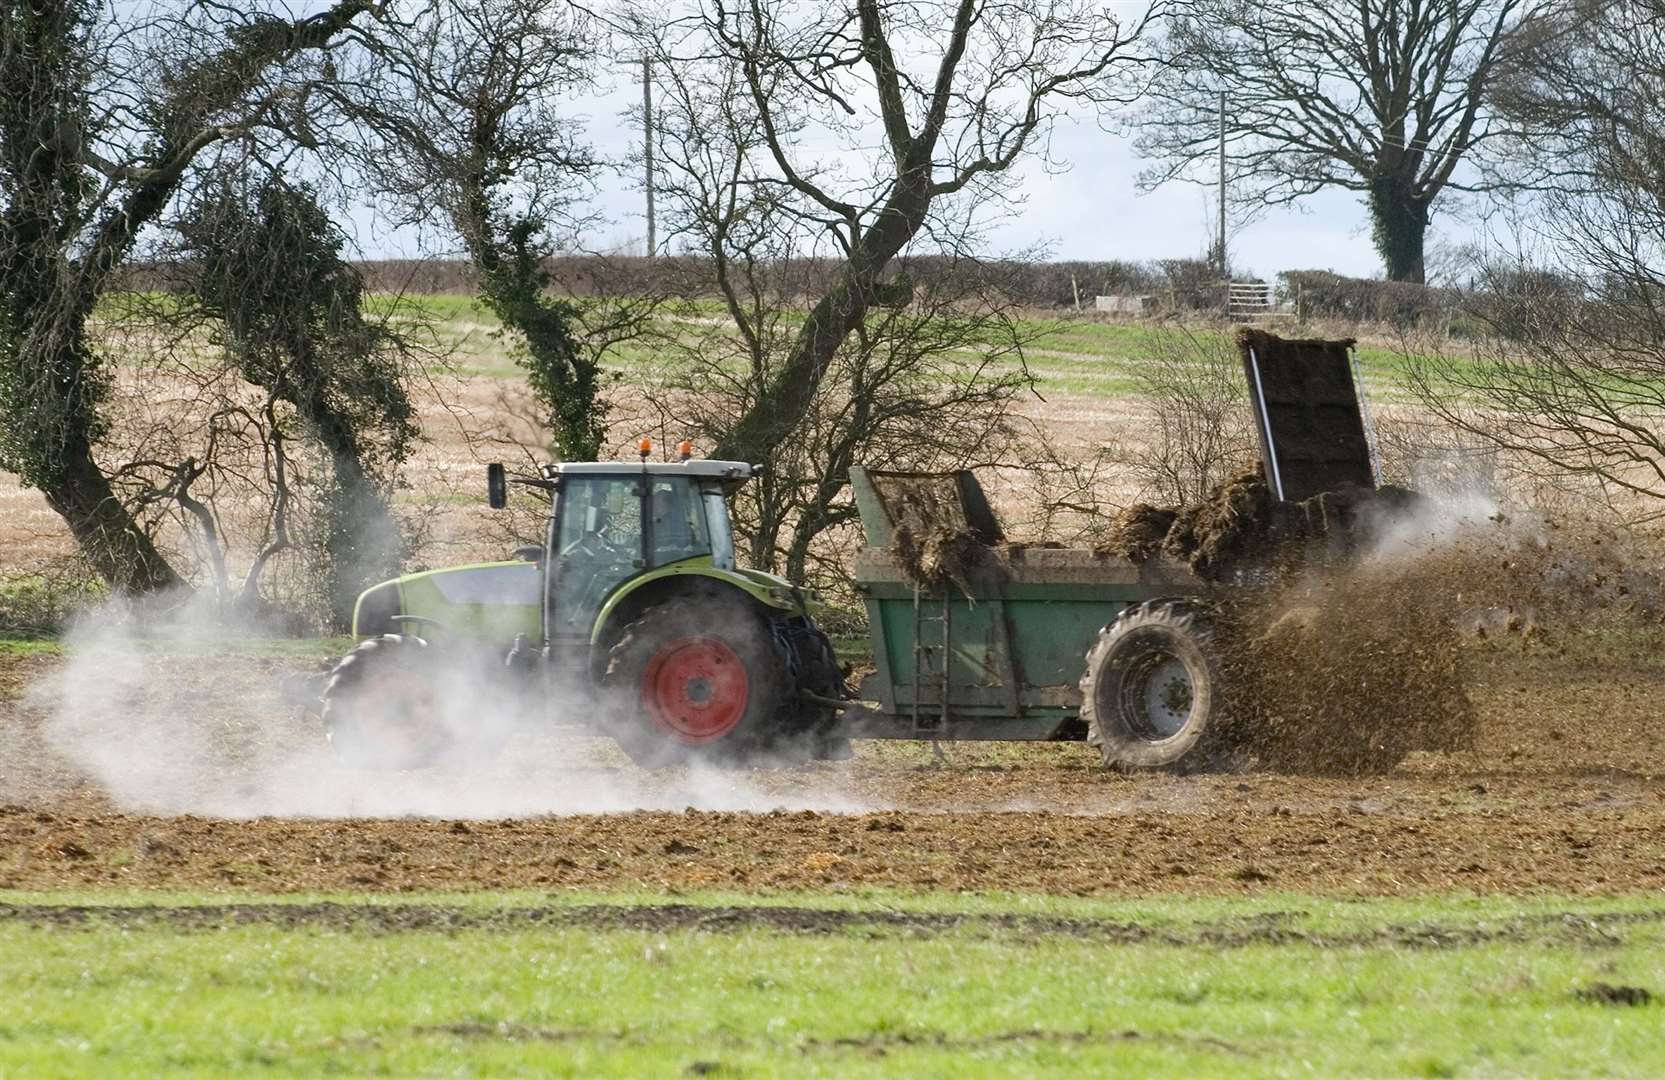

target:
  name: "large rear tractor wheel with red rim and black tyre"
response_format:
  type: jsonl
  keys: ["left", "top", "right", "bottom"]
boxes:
{"left": 604, "top": 596, "right": 793, "bottom": 769}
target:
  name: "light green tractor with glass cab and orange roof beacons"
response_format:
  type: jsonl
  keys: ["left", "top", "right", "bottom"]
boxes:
{"left": 321, "top": 444, "right": 847, "bottom": 769}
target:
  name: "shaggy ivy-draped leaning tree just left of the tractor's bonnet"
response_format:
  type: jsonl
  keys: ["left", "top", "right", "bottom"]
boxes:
{"left": 163, "top": 171, "right": 418, "bottom": 627}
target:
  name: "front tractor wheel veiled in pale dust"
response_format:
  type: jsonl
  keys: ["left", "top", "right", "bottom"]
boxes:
{"left": 323, "top": 634, "right": 513, "bottom": 770}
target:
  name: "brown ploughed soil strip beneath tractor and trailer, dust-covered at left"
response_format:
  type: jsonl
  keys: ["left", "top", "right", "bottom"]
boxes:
{"left": 0, "top": 642, "right": 1665, "bottom": 895}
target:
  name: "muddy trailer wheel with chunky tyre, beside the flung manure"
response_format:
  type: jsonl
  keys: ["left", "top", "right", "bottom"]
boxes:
{"left": 1081, "top": 601, "right": 1225, "bottom": 769}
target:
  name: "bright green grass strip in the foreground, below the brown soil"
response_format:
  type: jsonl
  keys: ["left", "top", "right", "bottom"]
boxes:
{"left": 0, "top": 894, "right": 1665, "bottom": 1077}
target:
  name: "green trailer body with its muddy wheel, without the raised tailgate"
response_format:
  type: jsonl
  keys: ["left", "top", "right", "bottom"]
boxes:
{"left": 841, "top": 468, "right": 1219, "bottom": 765}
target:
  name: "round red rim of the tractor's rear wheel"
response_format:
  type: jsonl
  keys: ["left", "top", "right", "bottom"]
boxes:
{"left": 641, "top": 637, "right": 751, "bottom": 744}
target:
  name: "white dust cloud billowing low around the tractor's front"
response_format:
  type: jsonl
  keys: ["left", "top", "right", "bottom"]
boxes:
{"left": 13, "top": 597, "right": 866, "bottom": 819}
